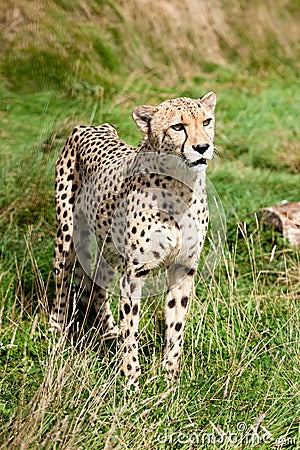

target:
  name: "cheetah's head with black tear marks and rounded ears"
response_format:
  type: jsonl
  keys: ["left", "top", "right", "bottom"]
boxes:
{"left": 132, "top": 92, "right": 216, "bottom": 167}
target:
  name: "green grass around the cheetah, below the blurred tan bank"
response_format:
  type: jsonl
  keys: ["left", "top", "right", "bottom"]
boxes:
{"left": 0, "top": 69, "right": 300, "bottom": 449}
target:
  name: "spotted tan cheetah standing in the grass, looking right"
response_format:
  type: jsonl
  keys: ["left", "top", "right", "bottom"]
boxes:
{"left": 50, "top": 92, "right": 216, "bottom": 390}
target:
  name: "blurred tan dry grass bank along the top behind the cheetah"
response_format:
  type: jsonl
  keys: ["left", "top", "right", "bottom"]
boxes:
{"left": 0, "top": 0, "right": 300, "bottom": 88}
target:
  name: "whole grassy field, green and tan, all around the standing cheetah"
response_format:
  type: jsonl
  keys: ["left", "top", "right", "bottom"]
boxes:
{"left": 0, "top": 0, "right": 300, "bottom": 450}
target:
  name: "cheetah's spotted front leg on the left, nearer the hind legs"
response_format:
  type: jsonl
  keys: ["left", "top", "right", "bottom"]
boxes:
{"left": 120, "top": 272, "right": 142, "bottom": 391}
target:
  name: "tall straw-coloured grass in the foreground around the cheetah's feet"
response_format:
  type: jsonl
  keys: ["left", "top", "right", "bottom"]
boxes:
{"left": 0, "top": 224, "right": 300, "bottom": 450}
